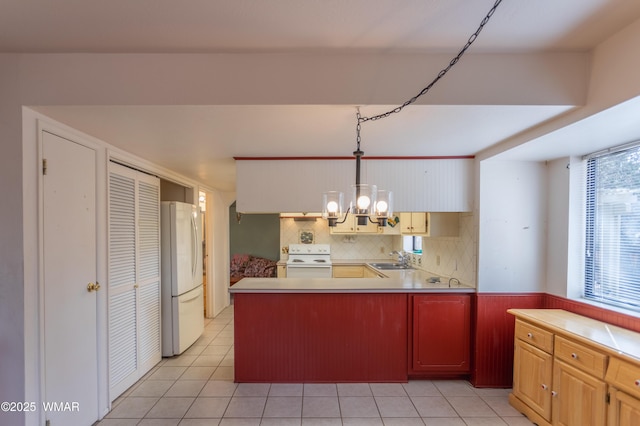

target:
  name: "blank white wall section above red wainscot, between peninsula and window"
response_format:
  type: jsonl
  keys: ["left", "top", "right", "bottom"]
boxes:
{"left": 477, "top": 160, "right": 547, "bottom": 293}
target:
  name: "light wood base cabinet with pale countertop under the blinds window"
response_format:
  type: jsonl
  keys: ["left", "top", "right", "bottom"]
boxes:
{"left": 509, "top": 309, "right": 640, "bottom": 426}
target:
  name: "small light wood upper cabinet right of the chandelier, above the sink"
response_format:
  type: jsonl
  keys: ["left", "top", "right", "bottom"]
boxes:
{"left": 400, "top": 212, "right": 460, "bottom": 237}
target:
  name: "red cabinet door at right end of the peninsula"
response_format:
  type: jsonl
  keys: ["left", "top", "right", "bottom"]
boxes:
{"left": 409, "top": 294, "right": 471, "bottom": 377}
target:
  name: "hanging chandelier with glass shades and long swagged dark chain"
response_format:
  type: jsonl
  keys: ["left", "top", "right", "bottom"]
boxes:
{"left": 322, "top": 0, "right": 502, "bottom": 227}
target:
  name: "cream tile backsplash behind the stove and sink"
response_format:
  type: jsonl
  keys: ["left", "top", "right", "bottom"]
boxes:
{"left": 280, "top": 213, "right": 477, "bottom": 286}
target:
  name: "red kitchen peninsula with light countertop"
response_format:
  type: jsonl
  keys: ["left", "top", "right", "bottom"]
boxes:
{"left": 230, "top": 271, "right": 475, "bottom": 383}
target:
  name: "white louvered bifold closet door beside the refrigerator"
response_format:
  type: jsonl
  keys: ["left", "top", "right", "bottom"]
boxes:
{"left": 108, "top": 163, "right": 161, "bottom": 400}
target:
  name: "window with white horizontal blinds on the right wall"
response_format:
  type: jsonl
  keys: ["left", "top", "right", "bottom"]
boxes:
{"left": 585, "top": 144, "right": 640, "bottom": 311}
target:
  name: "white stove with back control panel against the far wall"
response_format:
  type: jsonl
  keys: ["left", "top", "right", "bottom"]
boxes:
{"left": 287, "top": 244, "right": 332, "bottom": 278}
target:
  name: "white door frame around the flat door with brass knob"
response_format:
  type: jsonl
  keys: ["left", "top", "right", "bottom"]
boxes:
{"left": 23, "top": 115, "right": 110, "bottom": 424}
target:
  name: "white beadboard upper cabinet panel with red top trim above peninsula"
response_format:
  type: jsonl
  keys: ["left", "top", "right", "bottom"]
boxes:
{"left": 236, "top": 158, "right": 475, "bottom": 213}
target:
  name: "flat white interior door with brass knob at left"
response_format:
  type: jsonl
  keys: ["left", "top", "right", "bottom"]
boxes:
{"left": 38, "top": 131, "right": 98, "bottom": 426}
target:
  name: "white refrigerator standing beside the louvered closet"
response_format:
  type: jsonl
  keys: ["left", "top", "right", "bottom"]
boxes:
{"left": 160, "top": 201, "right": 204, "bottom": 357}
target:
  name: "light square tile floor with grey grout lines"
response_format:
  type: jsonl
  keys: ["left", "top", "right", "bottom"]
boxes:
{"left": 98, "top": 306, "right": 532, "bottom": 426}
